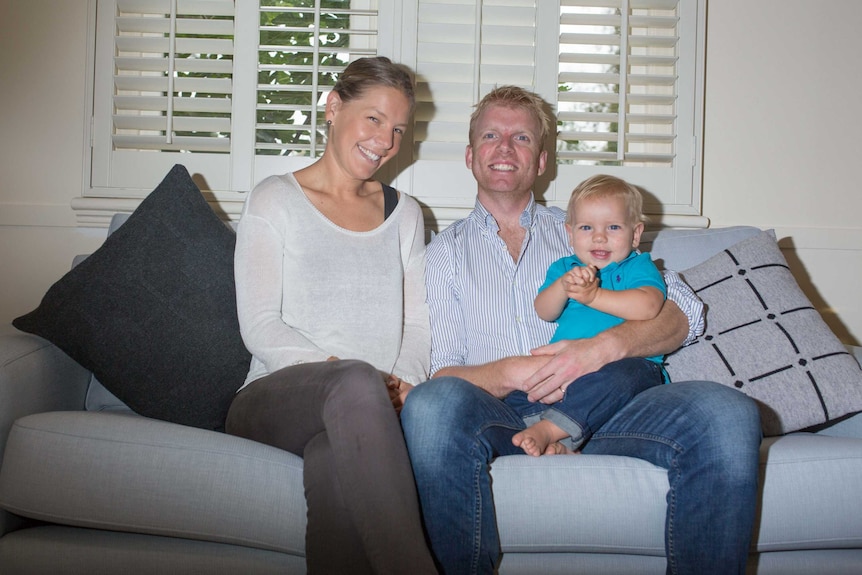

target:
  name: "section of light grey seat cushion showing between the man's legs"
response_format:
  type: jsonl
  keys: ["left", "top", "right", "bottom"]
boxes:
{"left": 491, "top": 455, "right": 668, "bottom": 557}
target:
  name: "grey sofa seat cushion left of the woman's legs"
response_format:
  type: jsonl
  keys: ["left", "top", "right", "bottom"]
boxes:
{"left": 0, "top": 411, "right": 306, "bottom": 556}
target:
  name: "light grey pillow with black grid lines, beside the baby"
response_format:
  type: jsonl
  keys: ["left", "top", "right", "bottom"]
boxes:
{"left": 666, "top": 232, "right": 862, "bottom": 435}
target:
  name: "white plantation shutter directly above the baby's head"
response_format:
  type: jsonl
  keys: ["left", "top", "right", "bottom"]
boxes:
{"left": 551, "top": 0, "right": 704, "bottom": 220}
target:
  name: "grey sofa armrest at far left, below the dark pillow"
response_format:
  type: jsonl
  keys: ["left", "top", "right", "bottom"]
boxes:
{"left": 0, "top": 325, "right": 90, "bottom": 534}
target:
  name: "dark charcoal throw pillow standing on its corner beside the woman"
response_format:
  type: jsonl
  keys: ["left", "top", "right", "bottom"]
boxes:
{"left": 12, "top": 165, "right": 251, "bottom": 430}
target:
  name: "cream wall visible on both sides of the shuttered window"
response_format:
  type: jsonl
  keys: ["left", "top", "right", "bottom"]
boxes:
{"left": 0, "top": 0, "right": 862, "bottom": 343}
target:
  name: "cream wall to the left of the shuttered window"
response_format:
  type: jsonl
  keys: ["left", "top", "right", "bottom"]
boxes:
{"left": 0, "top": 0, "right": 105, "bottom": 323}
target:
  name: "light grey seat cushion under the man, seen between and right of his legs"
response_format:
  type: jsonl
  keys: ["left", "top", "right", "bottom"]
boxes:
{"left": 491, "top": 433, "right": 862, "bottom": 560}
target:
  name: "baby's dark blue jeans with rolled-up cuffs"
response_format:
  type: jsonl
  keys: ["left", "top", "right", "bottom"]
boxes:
{"left": 503, "top": 357, "right": 664, "bottom": 449}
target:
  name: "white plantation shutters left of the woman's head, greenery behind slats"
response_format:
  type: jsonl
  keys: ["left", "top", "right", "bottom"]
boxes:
{"left": 88, "top": 0, "right": 384, "bottom": 214}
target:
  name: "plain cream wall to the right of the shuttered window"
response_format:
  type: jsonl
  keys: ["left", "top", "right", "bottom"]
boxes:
{"left": 703, "top": 0, "right": 862, "bottom": 344}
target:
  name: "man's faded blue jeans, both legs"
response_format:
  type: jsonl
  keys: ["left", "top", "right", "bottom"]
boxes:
{"left": 401, "top": 377, "right": 761, "bottom": 575}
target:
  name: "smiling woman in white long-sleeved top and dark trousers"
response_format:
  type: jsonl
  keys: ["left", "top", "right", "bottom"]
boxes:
{"left": 226, "top": 57, "right": 436, "bottom": 574}
